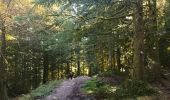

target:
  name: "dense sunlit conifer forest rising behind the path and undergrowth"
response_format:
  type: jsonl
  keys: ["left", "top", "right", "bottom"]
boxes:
{"left": 0, "top": 0, "right": 170, "bottom": 100}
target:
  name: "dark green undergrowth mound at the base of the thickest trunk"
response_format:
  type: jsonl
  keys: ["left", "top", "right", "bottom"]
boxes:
{"left": 115, "top": 80, "right": 156, "bottom": 98}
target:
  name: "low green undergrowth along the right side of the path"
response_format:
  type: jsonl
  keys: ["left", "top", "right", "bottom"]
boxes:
{"left": 82, "top": 78, "right": 157, "bottom": 100}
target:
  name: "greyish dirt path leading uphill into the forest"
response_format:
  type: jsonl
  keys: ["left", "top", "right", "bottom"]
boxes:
{"left": 40, "top": 76, "right": 90, "bottom": 100}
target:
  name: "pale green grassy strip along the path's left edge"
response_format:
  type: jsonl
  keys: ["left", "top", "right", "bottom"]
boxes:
{"left": 31, "top": 80, "right": 62, "bottom": 98}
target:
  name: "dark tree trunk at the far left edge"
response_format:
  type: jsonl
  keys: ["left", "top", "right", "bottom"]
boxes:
{"left": 0, "top": 22, "right": 8, "bottom": 100}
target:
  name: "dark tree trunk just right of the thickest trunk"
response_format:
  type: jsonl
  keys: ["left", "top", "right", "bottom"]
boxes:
{"left": 148, "top": 0, "right": 161, "bottom": 81}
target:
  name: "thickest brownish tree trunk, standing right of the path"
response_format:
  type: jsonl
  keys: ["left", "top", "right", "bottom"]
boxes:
{"left": 131, "top": 0, "right": 144, "bottom": 80}
